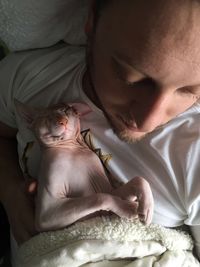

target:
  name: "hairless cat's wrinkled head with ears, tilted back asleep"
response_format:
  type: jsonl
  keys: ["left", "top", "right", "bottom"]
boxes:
{"left": 15, "top": 100, "right": 91, "bottom": 146}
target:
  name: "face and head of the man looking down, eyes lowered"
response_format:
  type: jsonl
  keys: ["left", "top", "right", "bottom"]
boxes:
{"left": 85, "top": 0, "right": 200, "bottom": 142}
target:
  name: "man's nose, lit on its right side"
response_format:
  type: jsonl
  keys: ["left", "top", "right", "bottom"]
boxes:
{"left": 134, "top": 92, "right": 173, "bottom": 132}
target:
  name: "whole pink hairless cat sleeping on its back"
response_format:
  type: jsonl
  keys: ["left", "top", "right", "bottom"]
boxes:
{"left": 15, "top": 100, "right": 153, "bottom": 231}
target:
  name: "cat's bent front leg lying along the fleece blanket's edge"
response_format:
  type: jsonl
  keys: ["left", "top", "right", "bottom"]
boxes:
{"left": 36, "top": 188, "right": 137, "bottom": 232}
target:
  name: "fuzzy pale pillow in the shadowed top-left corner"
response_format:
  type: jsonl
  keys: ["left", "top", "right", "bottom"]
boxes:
{"left": 0, "top": 0, "right": 89, "bottom": 51}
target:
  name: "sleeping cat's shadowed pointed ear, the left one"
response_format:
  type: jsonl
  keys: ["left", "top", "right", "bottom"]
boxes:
{"left": 14, "top": 98, "right": 36, "bottom": 128}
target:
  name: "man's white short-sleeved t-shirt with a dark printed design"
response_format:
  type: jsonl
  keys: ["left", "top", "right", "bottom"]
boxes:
{"left": 0, "top": 45, "right": 200, "bottom": 260}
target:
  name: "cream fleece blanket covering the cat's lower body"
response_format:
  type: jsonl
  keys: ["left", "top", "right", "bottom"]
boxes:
{"left": 17, "top": 216, "right": 200, "bottom": 267}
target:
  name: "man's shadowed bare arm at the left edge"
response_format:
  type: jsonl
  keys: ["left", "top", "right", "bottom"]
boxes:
{"left": 0, "top": 122, "right": 35, "bottom": 244}
